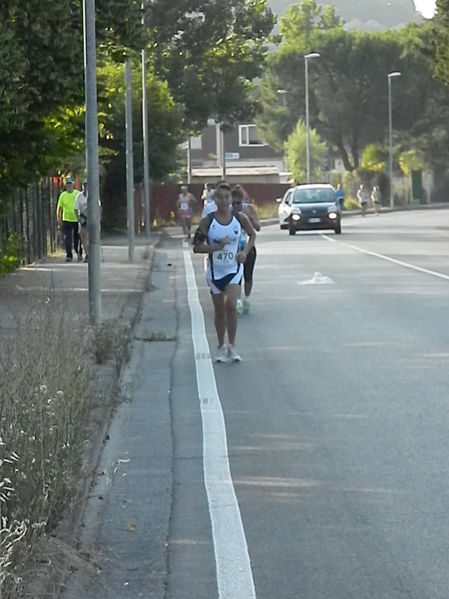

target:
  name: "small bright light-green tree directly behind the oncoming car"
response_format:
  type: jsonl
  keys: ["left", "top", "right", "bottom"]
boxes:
{"left": 285, "top": 120, "right": 327, "bottom": 181}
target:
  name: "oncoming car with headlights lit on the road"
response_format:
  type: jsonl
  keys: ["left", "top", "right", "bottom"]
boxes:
{"left": 277, "top": 183, "right": 341, "bottom": 235}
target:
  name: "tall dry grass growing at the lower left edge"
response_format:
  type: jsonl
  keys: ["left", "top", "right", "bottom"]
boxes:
{"left": 0, "top": 293, "right": 91, "bottom": 599}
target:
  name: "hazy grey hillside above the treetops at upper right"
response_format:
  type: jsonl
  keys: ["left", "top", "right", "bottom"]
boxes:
{"left": 268, "top": 0, "right": 421, "bottom": 31}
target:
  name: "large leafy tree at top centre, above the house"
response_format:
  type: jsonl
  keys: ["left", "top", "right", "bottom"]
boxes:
{"left": 146, "top": 0, "right": 274, "bottom": 130}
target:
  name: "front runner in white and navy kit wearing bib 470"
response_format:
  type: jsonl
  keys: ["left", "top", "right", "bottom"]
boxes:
{"left": 193, "top": 184, "right": 256, "bottom": 362}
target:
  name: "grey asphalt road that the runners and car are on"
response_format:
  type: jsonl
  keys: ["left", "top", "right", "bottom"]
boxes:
{"left": 62, "top": 210, "right": 449, "bottom": 599}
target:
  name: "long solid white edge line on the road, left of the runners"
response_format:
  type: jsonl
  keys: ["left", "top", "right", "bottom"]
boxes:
{"left": 183, "top": 249, "right": 256, "bottom": 599}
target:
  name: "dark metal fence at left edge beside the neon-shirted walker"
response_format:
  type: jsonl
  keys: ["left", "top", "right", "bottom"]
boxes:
{"left": 0, "top": 177, "right": 60, "bottom": 264}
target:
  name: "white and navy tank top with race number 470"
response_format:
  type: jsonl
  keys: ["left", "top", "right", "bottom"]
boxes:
{"left": 207, "top": 215, "right": 242, "bottom": 279}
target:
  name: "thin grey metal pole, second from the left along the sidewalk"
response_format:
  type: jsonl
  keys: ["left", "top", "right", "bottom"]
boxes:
{"left": 125, "top": 60, "right": 135, "bottom": 262}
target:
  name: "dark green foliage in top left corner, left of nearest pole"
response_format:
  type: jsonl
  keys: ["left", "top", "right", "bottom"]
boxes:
{"left": 0, "top": 0, "right": 83, "bottom": 197}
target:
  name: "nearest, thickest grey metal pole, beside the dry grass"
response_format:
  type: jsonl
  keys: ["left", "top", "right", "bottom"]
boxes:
{"left": 83, "top": 0, "right": 102, "bottom": 326}
